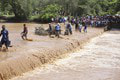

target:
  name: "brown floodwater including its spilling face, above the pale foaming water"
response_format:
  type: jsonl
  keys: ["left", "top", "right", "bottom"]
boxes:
{"left": 0, "top": 23, "right": 103, "bottom": 80}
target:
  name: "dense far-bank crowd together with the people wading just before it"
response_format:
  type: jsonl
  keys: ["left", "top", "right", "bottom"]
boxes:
{"left": 49, "top": 15, "right": 120, "bottom": 37}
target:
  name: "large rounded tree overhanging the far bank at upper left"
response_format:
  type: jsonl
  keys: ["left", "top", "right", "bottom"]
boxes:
{"left": 9, "top": 0, "right": 32, "bottom": 20}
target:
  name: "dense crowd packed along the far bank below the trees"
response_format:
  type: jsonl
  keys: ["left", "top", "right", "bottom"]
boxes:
{"left": 52, "top": 15, "right": 120, "bottom": 27}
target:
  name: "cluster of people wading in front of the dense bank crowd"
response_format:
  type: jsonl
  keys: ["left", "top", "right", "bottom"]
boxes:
{"left": 49, "top": 18, "right": 88, "bottom": 37}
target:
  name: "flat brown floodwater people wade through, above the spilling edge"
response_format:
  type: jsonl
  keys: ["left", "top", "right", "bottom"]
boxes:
{"left": 0, "top": 23, "right": 98, "bottom": 62}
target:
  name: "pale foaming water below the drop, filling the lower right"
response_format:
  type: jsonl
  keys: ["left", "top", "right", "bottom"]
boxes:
{"left": 12, "top": 31, "right": 120, "bottom": 80}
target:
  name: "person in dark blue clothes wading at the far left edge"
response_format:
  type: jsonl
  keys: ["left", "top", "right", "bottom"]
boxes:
{"left": 0, "top": 25, "right": 9, "bottom": 49}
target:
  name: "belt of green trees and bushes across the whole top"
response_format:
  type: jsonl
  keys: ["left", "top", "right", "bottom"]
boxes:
{"left": 0, "top": 0, "right": 120, "bottom": 21}
